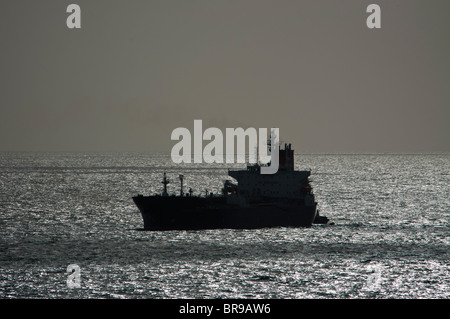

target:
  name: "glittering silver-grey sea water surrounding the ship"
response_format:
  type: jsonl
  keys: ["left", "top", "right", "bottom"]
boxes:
{"left": 0, "top": 153, "right": 450, "bottom": 298}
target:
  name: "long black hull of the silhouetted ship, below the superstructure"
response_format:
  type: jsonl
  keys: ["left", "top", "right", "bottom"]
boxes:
{"left": 133, "top": 196, "right": 317, "bottom": 230}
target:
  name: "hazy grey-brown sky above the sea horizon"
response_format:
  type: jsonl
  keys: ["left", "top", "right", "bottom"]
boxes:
{"left": 0, "top": 0, "right": 450, "bottom": 153}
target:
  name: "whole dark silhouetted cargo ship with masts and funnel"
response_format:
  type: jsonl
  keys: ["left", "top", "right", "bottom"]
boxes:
{"left": 133, "top": 144, "right": 328, "bottom": 230}
